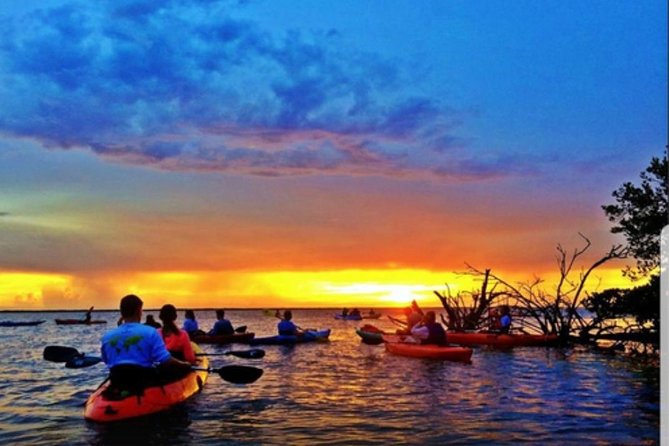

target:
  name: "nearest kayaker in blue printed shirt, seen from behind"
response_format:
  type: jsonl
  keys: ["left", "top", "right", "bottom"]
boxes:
{"left": 101, "top": 294, "right": 191, "bottom": 392}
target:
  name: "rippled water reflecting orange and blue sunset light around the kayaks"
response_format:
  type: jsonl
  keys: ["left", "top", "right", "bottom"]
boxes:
{"left": 0, "top": 310, "right": 659, "bottom": 445}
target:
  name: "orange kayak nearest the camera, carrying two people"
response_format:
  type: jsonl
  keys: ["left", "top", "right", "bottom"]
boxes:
{"left": 84, "top": 343, "right": 209, "bottom": 423}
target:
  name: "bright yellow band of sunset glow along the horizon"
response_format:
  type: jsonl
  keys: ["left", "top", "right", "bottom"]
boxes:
{"left": 0, "top": 268, "right": 630, "bottom": 309}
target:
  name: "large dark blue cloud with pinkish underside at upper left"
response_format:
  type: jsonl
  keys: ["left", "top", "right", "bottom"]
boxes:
{"left": 0, "top": 0, "right": 509, "bottom": 178}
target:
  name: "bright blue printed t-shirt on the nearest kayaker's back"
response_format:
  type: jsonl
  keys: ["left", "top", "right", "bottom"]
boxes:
{"left": 101, "top": 322, "right": 171, "bottom": 368}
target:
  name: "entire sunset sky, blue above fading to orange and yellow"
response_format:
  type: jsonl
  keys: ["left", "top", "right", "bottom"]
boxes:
{"left": 0, "top": 0, "right": 667, "bottom": 309}
